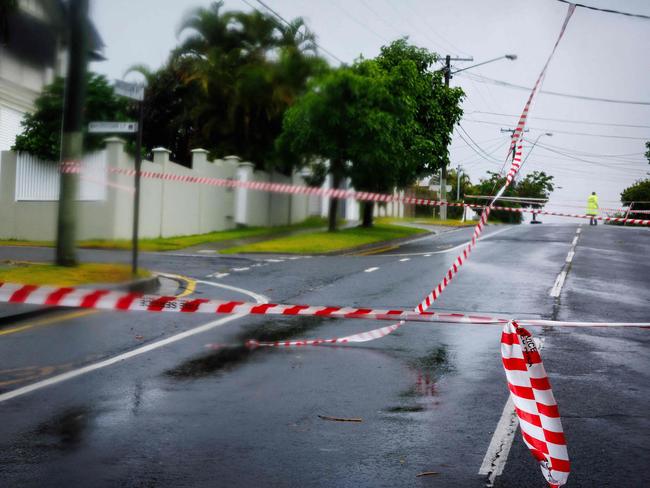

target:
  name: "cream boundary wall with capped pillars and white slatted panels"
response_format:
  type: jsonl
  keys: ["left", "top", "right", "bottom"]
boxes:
{"left": 0, "top": 138, "right": 313, "bottom": 241}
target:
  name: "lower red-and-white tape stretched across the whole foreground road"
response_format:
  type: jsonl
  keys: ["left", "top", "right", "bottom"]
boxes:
{"left": 0, "top": 282, "right": 650, "bottom": 328}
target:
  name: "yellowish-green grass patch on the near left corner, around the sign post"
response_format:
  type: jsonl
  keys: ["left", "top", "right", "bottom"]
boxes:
{"left": 0, "top": 261, "right": 151, "bottom": 286}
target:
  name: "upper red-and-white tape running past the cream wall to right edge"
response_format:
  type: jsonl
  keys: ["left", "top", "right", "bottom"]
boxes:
{"left": 61, "top": 164, "right": 650, "bottom": 225}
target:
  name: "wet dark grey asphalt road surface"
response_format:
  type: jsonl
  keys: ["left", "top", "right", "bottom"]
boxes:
{"left": 0, "top": 224, "right": 650, "bottom": 487}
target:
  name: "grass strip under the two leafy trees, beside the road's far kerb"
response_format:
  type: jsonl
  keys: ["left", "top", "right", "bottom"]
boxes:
{"left": 221, "top": 224, "right": 426, "bottom": 254}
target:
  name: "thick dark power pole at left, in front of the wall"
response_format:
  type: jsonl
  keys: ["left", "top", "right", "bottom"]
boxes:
{"left": 56, "top": 0, "right": 88, "bottom": 266}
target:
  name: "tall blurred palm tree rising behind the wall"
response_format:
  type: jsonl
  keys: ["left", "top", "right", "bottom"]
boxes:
{"left": 174, "top": 2, "right": 325, "bottom": 166}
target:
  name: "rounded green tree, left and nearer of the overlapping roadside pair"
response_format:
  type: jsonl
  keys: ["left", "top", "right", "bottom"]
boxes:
{"left": 277, "top": 61, "right": 414, "bottom": 231}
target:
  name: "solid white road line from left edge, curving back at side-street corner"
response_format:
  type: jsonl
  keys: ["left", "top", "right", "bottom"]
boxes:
{"left": 0, "top": 273, "right": 268, "bottom": 403}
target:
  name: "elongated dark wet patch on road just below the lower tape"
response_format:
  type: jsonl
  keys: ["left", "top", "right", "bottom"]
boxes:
{"left": 165, "top": 317, "right": 323, "bottom": 379}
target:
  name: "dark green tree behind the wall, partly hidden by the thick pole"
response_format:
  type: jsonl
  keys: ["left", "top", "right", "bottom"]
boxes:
{"left": 12, "top": 73, "right": 130, "bottom": 161}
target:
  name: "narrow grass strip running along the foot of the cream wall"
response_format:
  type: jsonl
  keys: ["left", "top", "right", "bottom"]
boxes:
{"left": 0, "top": 217, "right": 326, "bottom": 251}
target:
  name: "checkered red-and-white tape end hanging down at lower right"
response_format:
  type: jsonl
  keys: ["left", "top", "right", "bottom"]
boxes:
{"left": 501, "top": 321, "right": 571, "bottom": 487}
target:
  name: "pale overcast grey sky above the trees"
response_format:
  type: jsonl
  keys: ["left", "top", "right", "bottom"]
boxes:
{"left": 91, "top": 0, "right": 650, "bottom": 220}
